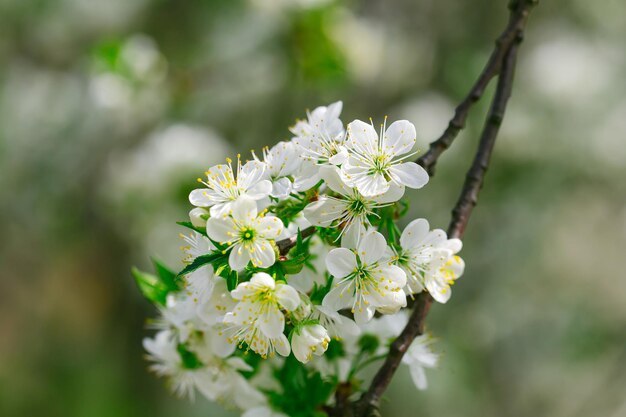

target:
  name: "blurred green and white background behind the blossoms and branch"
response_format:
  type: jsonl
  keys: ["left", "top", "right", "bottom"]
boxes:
{"left": 0, "top": 0, "right": 626, "bottom": 417}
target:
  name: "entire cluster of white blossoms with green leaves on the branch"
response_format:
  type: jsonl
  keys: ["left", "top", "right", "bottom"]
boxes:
{"left": 133, "top": 102, "right": 464, "bottom": 417}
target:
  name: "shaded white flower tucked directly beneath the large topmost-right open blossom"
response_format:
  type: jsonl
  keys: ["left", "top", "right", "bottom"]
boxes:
{"left": 304, "top": 169, "right": 404, "bottom": 247}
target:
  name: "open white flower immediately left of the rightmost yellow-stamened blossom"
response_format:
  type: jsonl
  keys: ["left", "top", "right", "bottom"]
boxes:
{"left": 322, "top": 232, "right": 406, "bottom": 325}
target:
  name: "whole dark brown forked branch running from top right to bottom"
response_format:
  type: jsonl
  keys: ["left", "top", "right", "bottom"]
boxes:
{"left": 355, "top": 0, "right": 536, "bottom": 416}
